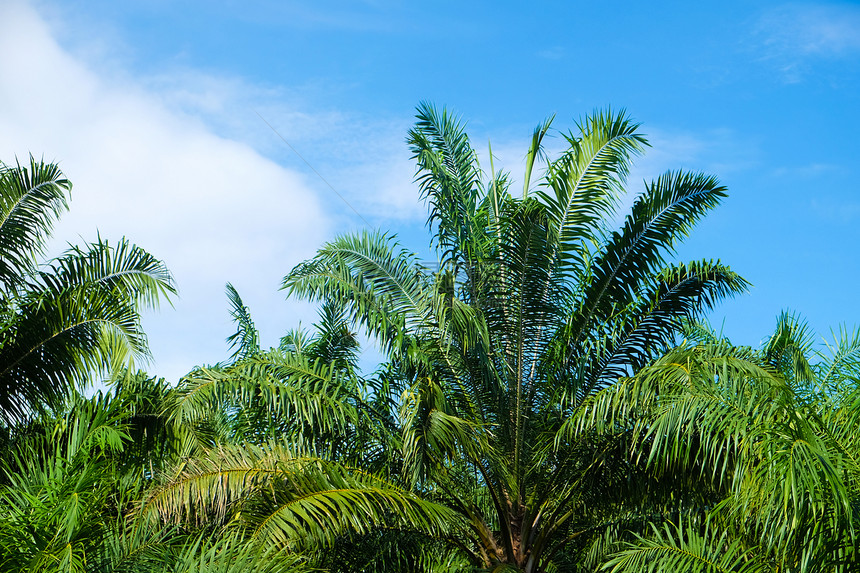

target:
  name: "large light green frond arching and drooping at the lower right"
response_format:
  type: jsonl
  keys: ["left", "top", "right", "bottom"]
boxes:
{"left": 568, "top": 344, "right": 857, "bottom": 570}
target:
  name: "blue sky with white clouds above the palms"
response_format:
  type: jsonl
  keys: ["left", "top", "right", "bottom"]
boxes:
{"left": 0, "top": 0, "right": 860, "bottom": 380}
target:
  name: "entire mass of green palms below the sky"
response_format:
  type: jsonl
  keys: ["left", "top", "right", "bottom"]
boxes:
{"left": 0, "top": 105, "right": 860, "bottom": 573}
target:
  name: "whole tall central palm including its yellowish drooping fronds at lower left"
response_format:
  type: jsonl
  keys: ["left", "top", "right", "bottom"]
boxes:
{"left": 150, "top": 104, "right": 746, "bottom": 572}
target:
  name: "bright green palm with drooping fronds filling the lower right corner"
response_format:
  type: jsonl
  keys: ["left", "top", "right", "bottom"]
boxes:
{"left": 596, "top": 313, "right": 860, "bottom": 573}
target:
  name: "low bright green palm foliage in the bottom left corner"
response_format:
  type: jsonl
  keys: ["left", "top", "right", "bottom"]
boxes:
{"left": 0, "top": 373, "right": 316, "bottom": 573}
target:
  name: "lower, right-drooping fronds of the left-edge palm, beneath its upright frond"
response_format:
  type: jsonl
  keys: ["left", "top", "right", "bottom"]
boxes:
{"left": 0, "top": 240, "right": 175, "bottom": 419}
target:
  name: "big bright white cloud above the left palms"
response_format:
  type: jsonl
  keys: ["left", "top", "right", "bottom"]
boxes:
{"left": 0, "top": 2, "right": 333, "bottom": 384}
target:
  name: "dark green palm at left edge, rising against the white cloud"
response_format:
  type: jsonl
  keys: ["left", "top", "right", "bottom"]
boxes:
{"left": 0, "top": 157, "right": 175, "bottom": 423}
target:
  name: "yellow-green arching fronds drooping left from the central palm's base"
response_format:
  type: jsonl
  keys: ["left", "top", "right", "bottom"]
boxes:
{"left": 143, "top": 446, "right": 464, "bottom": 548}
